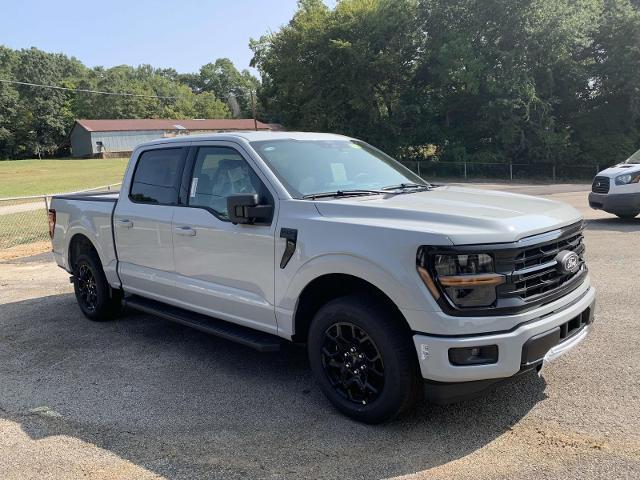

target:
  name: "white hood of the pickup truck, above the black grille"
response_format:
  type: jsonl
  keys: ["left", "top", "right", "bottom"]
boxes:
{"left": 316, "top": 186, "right": 582, "bottom": 245}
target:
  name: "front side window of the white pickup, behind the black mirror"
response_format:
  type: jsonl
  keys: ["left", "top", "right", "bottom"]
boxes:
{"left": 189, "top": 147, "right": 272, "bottom": 219}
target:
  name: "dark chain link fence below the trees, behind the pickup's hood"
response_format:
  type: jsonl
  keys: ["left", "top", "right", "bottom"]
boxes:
{"left": 402, "top": 160, "right": 605, "bottom": 183}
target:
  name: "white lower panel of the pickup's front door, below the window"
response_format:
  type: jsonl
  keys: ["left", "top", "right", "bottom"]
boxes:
{"left": 173, "top": 208, "right": 276, "bottom": 331}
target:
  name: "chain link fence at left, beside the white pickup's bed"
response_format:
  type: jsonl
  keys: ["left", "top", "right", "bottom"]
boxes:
{"left": 0, "top": 183, "right": 120, "bottom": 252}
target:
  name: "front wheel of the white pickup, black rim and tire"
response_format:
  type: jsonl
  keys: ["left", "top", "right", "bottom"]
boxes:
{"left": 308, "top": 295, "right": 422, "bottom": 424}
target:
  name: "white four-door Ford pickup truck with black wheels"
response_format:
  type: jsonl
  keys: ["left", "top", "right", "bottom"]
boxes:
{"left": 50, "top": 132, "right": 595, "bottom": 423}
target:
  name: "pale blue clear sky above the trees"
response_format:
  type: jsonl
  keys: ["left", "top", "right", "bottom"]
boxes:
{"left": 0, "top": 0, "right": 335, "bottom": 73}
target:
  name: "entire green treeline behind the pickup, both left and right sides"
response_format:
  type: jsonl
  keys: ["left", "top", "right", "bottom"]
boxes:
{"left": 5, "top": 0, "right": 640, "bottom": 165}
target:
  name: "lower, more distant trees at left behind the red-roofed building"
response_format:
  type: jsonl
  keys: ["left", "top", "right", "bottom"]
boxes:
{"left": 0, "top": 46, "right": 257, "bottom": 158}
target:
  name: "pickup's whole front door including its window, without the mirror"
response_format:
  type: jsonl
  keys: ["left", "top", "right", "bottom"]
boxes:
{"left": 173, "top": 145, "right": 277, "bottom": 333}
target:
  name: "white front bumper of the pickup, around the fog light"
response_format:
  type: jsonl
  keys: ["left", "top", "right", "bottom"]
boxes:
{"left": 413, "top": 287, "right": 596, "bottom": 390}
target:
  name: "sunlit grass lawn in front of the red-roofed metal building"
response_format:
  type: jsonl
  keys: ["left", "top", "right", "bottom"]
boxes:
{"left": 0, "top": 158, "right": 129, "bottom": 198}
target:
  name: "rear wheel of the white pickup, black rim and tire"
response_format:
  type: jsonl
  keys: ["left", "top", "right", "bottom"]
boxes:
{"left": 73, "top": 251, "right": 122, "bottom": 322}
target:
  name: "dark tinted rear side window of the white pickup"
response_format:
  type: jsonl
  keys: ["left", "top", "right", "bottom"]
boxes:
{"left": 129, "top": 148, "right": 184, "bottom": 205}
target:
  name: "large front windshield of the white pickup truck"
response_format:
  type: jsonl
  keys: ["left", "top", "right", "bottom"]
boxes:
{"left": 251, "top": 139, "right": 429, "bottom": 198}
